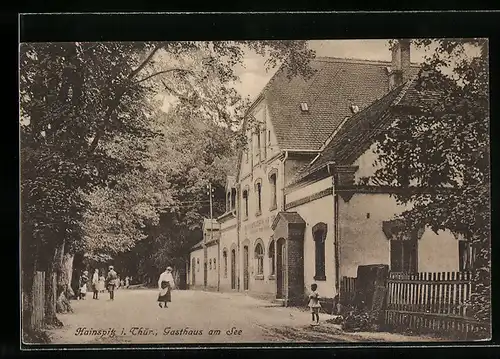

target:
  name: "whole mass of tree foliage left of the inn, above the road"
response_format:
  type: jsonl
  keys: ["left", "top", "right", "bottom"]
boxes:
{"left": 20, "top": 41, "right": 314, "bottom": 318}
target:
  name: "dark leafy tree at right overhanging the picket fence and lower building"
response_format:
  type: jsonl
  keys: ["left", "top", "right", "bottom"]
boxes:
{"left": 373, "top": 39, "right": 491, "bottom": 333}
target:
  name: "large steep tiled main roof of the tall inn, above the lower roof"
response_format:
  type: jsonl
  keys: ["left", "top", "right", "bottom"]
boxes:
{"left": 263, "top": 57, "right": 418, "bottom": 150}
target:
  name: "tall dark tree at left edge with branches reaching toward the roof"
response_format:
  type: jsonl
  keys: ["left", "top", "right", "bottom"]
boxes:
{"left": 20, "top": 41, "right": 313, "bottom": 330}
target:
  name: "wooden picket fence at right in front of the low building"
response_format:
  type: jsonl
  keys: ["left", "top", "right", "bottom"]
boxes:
{"left": 385, "top": 272, "right": 481, "bottom": 337}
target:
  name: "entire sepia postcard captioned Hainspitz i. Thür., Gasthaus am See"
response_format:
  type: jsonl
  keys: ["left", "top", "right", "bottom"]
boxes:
{"left": 19, "top": 38, "right": 491, "bottom": 348}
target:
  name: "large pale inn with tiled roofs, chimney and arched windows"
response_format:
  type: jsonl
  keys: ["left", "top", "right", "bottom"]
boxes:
{"left": 188, "top": 41, "right": 470, "bottom": 310}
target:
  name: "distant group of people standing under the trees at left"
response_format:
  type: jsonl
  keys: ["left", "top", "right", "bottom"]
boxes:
{"left": 77, "top": 266, "right": 131, "bottom": 300}
